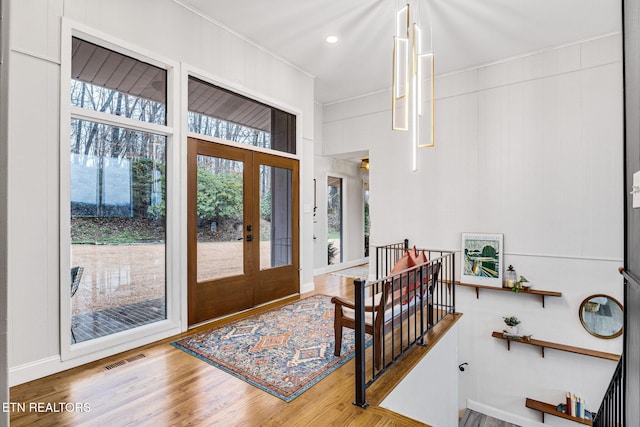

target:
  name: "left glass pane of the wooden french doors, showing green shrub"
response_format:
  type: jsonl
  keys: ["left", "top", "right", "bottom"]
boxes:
{"left": 196, "top": 155, "right": 244, "bottom": 282}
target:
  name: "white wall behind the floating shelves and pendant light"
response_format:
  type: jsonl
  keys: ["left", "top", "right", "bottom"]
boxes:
{"left": 323, "top": 34, "right": 623, "bottom": 425}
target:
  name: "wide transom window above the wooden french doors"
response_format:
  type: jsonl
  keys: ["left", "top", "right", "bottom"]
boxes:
{"left": 188, "top": 77, "right": 296, "bottom": 154}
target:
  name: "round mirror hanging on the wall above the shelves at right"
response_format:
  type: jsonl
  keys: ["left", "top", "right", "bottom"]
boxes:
{"left": 580, "top": 294, "right": 624, "bottom": 339}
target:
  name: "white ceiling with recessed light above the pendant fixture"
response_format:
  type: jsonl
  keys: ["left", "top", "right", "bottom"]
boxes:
{"left": 175, "top": 0, "right": 622, "bottom": 104}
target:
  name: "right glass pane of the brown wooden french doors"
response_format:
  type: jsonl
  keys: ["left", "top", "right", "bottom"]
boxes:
{"left": 260, "top": 165, "right": 292, "bottom": 270}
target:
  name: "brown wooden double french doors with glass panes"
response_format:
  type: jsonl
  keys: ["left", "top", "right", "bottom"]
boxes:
{"left": 187, "top": 138, "right": 300, "bottom": 325}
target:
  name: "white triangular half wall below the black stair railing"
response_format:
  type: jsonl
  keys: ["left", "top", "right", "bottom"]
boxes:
{"left": 380, "top": 324, "right": 461, "bottom": 427}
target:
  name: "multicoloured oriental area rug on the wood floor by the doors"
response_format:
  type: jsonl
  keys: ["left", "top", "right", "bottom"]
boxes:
{"left": 172, "top": 295, "right": 355, "bottom": 402}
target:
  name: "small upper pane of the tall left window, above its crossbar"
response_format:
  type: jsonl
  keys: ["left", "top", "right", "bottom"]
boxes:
{"left": 71, "top": 37, "right": 167, "bottom": 125}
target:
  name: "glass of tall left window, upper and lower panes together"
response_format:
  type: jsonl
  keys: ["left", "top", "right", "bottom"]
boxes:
{"left": 69, "top": 37, "right": 167, "bottom": 343}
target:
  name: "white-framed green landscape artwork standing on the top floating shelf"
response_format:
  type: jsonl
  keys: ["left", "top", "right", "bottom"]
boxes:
{"left": 460, "top": 233, "right": 504, "bottom": 288}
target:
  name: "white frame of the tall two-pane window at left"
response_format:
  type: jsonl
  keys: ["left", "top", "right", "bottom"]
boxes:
{"left": 60, "top": 18, "right": 181, "bottom": 365}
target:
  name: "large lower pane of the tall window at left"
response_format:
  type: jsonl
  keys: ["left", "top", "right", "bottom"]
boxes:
{"left": 70, "top": 120, "right": 166, "bottom": 342}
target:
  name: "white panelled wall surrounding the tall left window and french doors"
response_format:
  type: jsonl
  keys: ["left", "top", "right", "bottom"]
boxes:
{"left": 3, "top": 0, "right": 314, "bottom": 384}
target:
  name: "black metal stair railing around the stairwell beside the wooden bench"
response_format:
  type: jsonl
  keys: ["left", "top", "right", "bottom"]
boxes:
{"left": 353, "top": 241, "right": 455, "bottom": 408}
